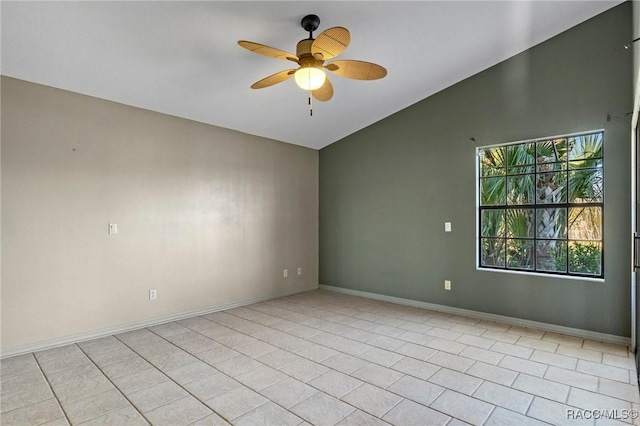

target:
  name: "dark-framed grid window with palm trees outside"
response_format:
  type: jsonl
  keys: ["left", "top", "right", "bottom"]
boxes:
{"left": 478, "top": 131, "right": 604, "bottom": 278}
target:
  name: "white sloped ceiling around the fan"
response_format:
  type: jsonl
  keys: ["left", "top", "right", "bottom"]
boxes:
{"left": 0, "top": 1, "right": 621, "bottom": 149}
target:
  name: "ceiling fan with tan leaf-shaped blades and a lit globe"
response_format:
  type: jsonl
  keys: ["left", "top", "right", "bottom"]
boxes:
{"left": 238, "top": 15, "right": 387, "bottom": 106}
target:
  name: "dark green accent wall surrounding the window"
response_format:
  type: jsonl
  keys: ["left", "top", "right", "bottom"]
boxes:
{"left": 319, "top": 2, "right": 633, "bottom": 337}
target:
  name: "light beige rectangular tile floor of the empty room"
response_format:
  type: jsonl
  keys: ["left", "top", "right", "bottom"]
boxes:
{"left": 0, "top": 291, "right": 640, "bottom": 426}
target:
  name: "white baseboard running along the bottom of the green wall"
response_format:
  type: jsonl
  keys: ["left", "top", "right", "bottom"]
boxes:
{"left": 318, "top": 284, "right": 631, "bottom": 346}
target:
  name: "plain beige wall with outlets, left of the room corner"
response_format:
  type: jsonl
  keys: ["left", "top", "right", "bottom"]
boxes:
{"left": 1, "top": 77, "right": 318, "bottom": 353}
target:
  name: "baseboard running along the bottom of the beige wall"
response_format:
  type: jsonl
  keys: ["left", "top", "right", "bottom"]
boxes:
{"left": 0, "top": 285, "right": 318, "bottom": 358}
